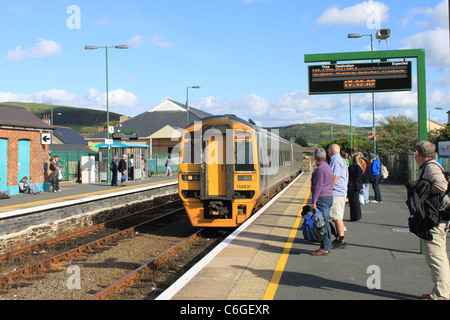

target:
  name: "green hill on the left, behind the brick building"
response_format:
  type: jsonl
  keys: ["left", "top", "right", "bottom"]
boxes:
{"left": 4, "top": 102, "right": 121, "bottom": 133}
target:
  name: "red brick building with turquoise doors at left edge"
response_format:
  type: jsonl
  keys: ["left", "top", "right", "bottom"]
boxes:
{"left": 0, "top": 104, "right": 53, "bottom": 195}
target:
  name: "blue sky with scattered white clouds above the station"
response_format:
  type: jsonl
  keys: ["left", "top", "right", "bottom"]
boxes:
{"left": 0, "top": 0, "right": 450, "bottom": 126}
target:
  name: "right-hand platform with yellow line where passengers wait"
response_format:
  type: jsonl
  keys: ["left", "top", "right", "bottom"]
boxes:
{"left": 157, "top": 173, "right": 448, "bottom": 300}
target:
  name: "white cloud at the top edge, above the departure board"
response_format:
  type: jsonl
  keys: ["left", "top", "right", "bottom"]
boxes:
{"left": 316, "top": 0, "right": 390, "bottom": 29}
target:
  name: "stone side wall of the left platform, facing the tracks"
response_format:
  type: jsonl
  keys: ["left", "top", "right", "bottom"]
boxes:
{"left": 0, "top": 185, "right": 178, "bottom": 254}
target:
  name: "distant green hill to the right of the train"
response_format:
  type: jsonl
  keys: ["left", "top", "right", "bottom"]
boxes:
{"left": 271, "top": 123, "right": 372, "bottom": 147}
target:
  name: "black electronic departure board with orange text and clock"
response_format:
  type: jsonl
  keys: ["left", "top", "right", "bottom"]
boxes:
{"left": 309, "top": 61, "right": 412, "bottom": 94}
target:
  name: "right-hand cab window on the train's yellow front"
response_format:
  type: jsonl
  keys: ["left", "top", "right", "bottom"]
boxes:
{"left": 235, "top": 130, "right": 255, "bottom": 172}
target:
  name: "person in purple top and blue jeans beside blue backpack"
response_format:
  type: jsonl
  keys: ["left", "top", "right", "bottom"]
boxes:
{"left": 311, "top": 148, "right": 333, "bottom": 256}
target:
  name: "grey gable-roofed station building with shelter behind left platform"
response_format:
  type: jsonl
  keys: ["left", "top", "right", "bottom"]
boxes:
{"left": 86, "top": 98, "right": 211, "bottom": 181}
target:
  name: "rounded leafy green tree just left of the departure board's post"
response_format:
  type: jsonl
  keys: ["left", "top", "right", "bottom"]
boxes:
{"left": 377, "top": 113, "right": 419, "bottom": 155}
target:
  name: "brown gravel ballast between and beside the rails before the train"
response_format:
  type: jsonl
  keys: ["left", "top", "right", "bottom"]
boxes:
{"left": 0, "top": 219, "right": 224, "bottom": 300}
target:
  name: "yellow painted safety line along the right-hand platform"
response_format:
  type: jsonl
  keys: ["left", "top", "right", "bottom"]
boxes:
{"left": 263, "top": 188, "right": 311, "bottom": 300}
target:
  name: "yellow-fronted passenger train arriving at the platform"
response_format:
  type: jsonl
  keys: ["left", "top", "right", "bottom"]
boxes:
{"left": 178, "top": 115, "right": 303, "bottom": 227}
